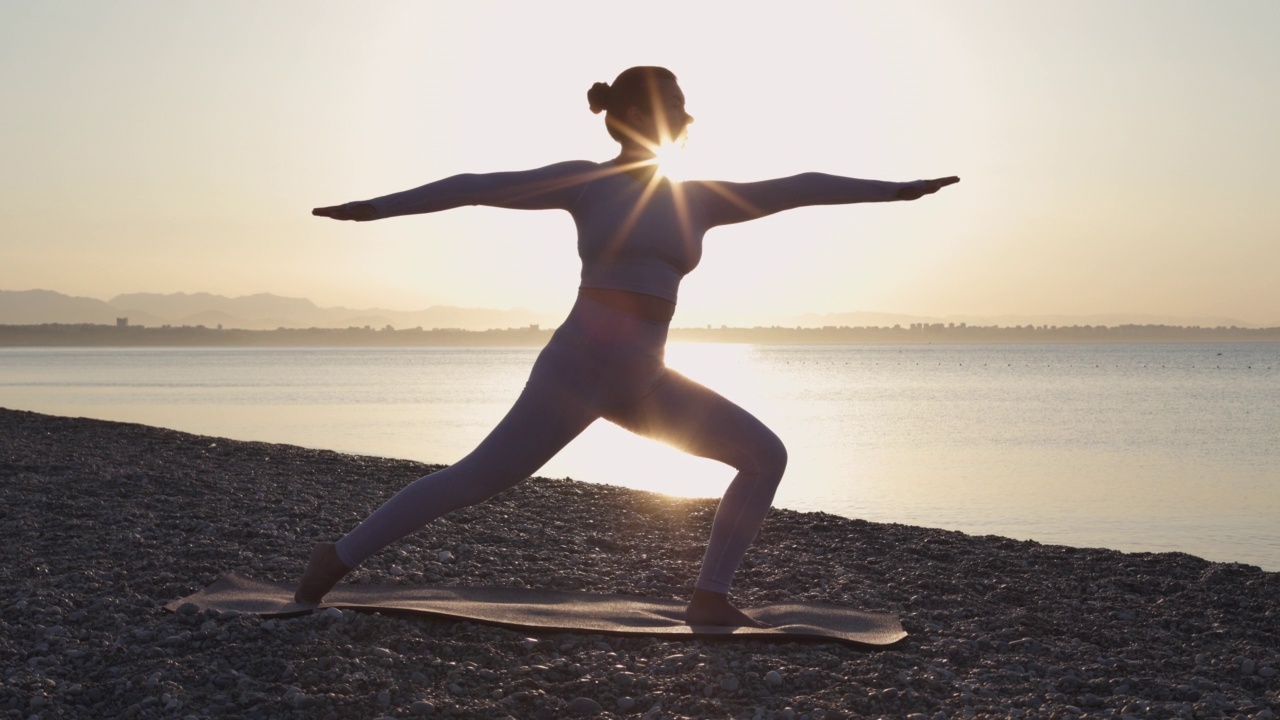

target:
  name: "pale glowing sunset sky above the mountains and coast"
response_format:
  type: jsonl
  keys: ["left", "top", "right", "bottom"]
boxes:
{"left": 0, "top": 0, "right": 1280, "bottom": 325}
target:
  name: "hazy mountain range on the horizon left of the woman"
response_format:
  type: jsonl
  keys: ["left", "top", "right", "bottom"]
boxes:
{"left": 0, "top": 290, "right": 558, "bottom": 331}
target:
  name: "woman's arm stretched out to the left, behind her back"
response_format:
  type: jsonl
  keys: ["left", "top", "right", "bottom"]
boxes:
{"left": 311, "top": 160, "right": 599, "bottom": 220}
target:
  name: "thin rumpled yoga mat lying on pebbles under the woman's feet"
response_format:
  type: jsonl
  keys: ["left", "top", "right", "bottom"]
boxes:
{"left": 165, "top": 573, "right": 906, "bottom": 647}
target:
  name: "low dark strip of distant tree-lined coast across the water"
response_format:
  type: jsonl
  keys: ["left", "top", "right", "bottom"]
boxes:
{"left": 0, "top": 323, "right": 1280, "bottom": 347}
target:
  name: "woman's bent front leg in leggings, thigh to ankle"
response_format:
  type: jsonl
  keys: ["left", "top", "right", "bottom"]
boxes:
{"left": 607, "top": 370, "right": 787, "bottom": 596}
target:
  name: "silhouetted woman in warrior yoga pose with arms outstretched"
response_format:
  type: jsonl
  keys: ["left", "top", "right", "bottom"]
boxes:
{"left": 302, "top": 67, "right": 959, "bottom": 626}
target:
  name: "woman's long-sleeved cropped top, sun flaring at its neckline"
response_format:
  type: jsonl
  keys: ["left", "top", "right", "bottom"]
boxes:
{"left": 365, "top": 161, "right": 909, "bottom": 302}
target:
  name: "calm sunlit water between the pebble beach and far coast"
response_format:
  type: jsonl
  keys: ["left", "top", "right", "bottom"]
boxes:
{"left": 0, "top": 343, "right": 1280, "bottom": 570}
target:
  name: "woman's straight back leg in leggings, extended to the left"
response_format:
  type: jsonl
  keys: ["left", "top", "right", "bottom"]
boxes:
{"left": 337, "top": 382, "right": 598, "bottom": 568}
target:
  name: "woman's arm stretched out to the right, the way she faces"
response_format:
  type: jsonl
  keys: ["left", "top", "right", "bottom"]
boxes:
{"left": 696, "top": 173, "right": 960, "bottom": 225}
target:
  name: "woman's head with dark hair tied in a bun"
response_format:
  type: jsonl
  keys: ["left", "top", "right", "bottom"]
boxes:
{"left": 586, "top": 67, "right": 694, "bottom": 150}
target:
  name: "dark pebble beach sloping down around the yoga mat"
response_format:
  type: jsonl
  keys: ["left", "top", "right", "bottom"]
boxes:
{"left": 0, "top": 410, "right": 1280, "bottom": 720}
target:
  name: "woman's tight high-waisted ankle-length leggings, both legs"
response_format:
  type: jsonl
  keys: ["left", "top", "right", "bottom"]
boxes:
{"left": 338, "top": 292, "right": 787, "bottom": 593}
